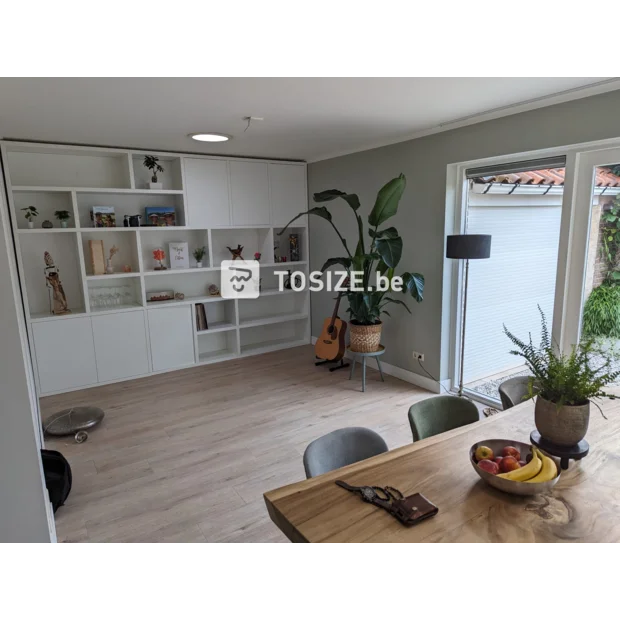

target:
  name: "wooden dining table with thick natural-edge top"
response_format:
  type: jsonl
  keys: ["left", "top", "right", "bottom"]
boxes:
{"left": 264, "top": 398, "right": 620, "bottom": 543}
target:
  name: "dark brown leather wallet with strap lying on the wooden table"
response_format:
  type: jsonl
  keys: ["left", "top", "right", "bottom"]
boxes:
{"left": 336, "top": 480, "right": 439, "bottom": 525}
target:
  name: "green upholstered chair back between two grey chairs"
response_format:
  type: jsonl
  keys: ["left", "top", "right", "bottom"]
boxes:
{"left": 409, "top": 396, "right": 480, "bottom": 441}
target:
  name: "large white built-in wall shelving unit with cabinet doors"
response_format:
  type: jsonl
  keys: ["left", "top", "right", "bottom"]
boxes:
{"left": 0, "top": 141, "right": 310, "bottom": 396}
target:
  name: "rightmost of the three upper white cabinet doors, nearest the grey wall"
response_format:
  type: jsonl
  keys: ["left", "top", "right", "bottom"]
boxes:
{"left": 269, "top": 164, "right": 308, "bottom": 226}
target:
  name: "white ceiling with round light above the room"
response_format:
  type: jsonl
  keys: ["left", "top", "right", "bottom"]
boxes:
{"left": 0, "top": 72, "right": 620, "bottom": 161}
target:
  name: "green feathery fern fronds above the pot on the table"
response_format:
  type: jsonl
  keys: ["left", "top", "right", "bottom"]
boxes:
{"left": 504, "top": 306, "right": 620, "bottom": 413}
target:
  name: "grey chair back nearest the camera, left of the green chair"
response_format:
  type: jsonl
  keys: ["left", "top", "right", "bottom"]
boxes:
{"left": 304, "top": 426, "right": 388, "bottom": 478}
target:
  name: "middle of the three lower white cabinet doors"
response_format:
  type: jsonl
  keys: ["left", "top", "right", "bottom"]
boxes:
{"left": 92, "top": 311, "right": 149, "bottom": 381}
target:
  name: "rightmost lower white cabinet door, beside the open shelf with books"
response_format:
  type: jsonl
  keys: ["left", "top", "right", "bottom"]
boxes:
{"left": 148, "top": 306, "right": 196, "bottom": 371}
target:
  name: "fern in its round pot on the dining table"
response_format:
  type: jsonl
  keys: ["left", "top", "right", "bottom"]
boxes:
{"left": 504, "top": 306, "right": 620, "bottom": 446}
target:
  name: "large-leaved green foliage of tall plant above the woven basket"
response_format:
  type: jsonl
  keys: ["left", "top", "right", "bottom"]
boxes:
{"left": 278, "top": 174, "right": 424, "bottom": 325}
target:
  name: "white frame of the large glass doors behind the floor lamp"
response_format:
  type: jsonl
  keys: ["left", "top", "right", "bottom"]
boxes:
{"left": 441, "top": 137, "right": 620, "bottom": 405}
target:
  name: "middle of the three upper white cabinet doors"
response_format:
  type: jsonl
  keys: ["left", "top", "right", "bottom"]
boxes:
{"left": 230, "top": 161, "right": 270, "bottom": 226}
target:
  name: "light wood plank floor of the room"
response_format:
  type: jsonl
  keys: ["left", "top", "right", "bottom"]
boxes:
{"left": 41, "top": 346, "right": 430, "bottom": 543}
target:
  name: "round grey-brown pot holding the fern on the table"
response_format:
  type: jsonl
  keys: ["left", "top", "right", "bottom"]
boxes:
{"left": 534, "top": 396, "right": 590, "bottom": 446}
